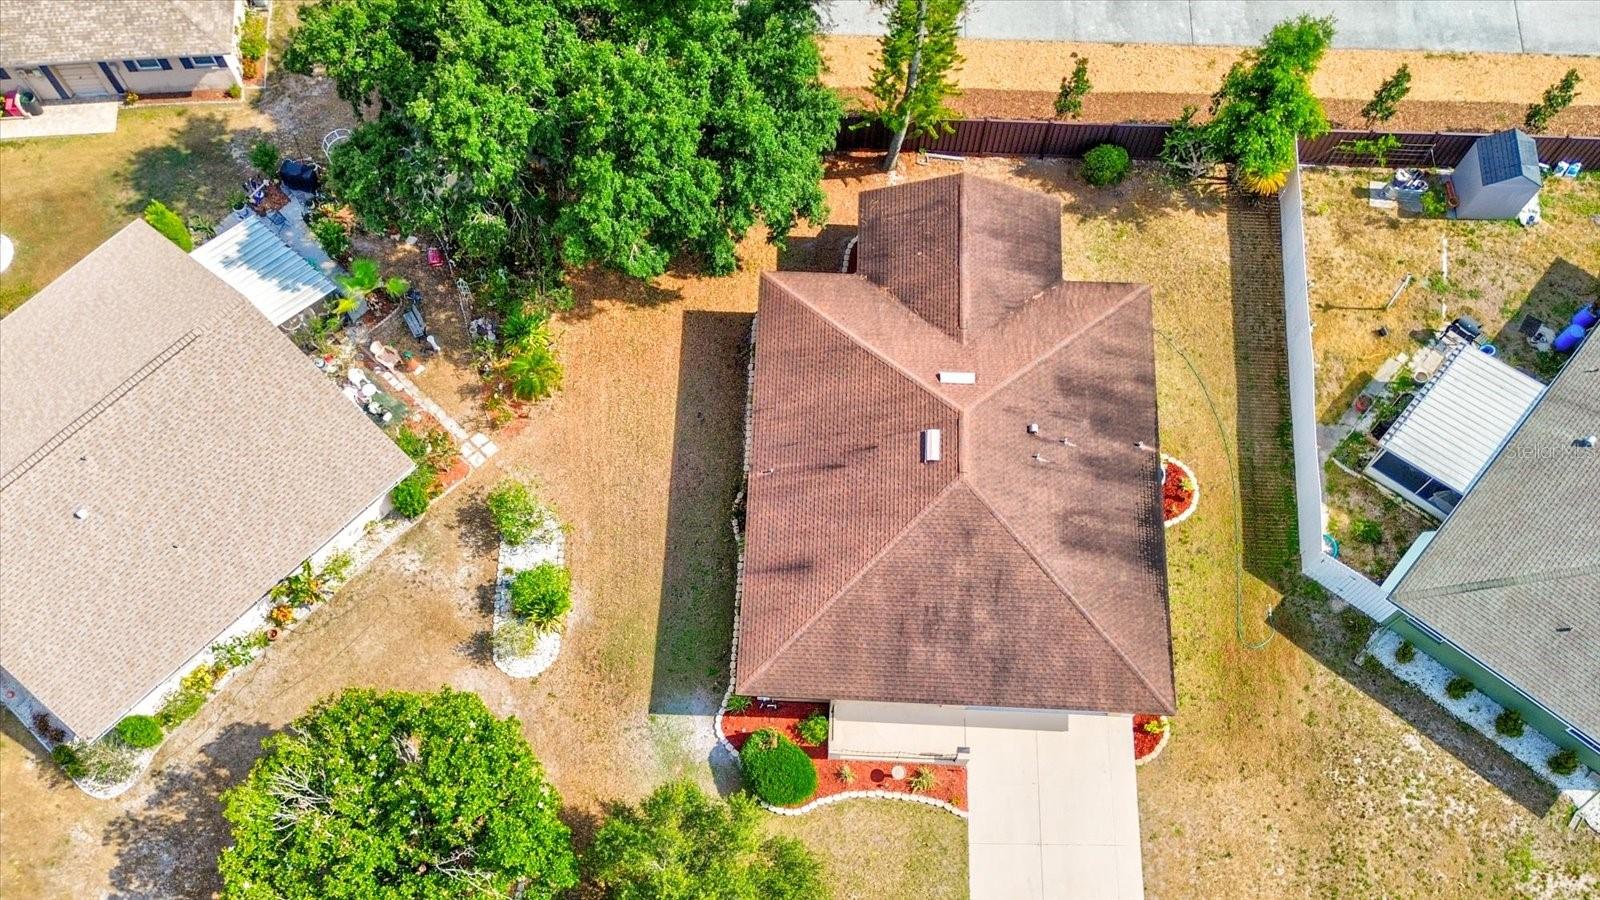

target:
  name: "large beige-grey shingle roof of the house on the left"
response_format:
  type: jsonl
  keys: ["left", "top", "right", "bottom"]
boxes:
{"left": 0, "top": 221, "right": 411, "bottom": 737}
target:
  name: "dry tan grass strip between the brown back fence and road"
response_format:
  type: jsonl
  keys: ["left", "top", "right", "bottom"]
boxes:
{"left": 819, "top": 35, "right": 1600, "bottom": 126}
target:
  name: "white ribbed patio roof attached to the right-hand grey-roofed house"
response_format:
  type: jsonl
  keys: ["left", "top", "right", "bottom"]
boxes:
{"left": 1382, "top": 339, "right": 1544, "bottom": 493}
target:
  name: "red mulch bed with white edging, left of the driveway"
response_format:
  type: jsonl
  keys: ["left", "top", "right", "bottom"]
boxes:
{"left": 722, "top": 701, "right": 966, "bottom": 809}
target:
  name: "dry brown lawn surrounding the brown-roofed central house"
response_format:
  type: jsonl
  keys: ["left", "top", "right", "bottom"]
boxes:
{"left": 0, "top": 159, "right": 1600, "bottom": 898}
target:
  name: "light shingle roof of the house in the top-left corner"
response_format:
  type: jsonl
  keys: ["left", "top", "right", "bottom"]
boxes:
{"left": 0, "top": 0, "right": 235, "bottom": 66}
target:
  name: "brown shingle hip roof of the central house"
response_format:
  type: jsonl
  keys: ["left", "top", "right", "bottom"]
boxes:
{"left": 734, "top": 176, "right": 1176, "bottom": 713}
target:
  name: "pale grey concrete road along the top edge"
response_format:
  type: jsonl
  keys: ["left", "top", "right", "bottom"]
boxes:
{"left": 822, "top": 0, "right": 1600, "bottom": 56}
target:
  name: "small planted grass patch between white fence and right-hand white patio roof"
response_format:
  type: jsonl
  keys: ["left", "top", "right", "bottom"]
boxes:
{"left": 1322, "top": 463, "right": 1438, "bottom": 583}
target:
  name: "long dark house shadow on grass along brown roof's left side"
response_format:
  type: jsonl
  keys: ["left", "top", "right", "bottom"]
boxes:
{"left": 650, "top": 309, "right": 750, "bottom": 716}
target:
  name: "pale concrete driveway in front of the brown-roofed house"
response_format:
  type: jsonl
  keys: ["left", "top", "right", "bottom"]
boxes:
{"left": 966, "top": 711, "right": 1144, "bottom": 900}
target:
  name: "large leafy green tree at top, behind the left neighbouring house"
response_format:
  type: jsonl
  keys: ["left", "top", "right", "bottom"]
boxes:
{"left": 285, "top": 0, "right": 840, "bottom": 277}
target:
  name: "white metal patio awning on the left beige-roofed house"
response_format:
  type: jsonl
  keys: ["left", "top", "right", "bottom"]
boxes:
{"left": 190, "top": 216, "right": 339, "bottom": 325}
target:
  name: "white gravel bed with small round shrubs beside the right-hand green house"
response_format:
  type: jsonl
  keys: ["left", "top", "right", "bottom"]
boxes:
{"left": 1366, "top": 631, "right": 1600, "bottom": 831}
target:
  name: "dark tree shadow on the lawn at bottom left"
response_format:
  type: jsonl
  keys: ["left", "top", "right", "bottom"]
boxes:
{"left": 102, "top": 722, "right": 272, "bottom": 900}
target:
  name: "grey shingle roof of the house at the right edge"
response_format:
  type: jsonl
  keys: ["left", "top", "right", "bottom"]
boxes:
{"left": 1394, "top": 329, "right": 1600, "bottom": 737}
